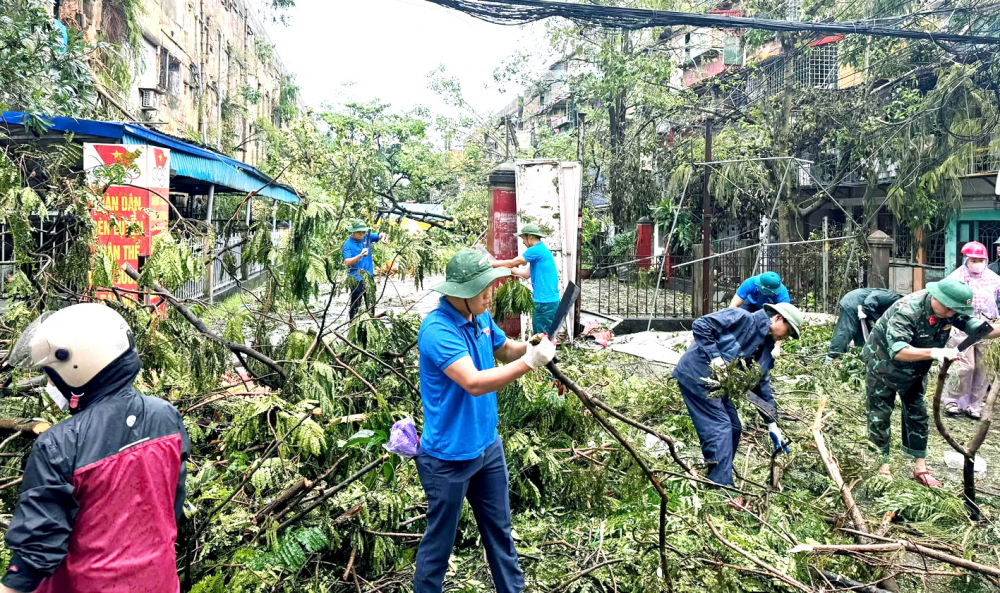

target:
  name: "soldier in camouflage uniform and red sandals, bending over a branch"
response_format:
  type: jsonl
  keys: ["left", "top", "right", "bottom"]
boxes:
{"left": 862, "top": 278, "right": 1000, "bottom": 487}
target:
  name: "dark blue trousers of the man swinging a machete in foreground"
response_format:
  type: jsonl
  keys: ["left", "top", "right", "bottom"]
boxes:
{"left": 413, "top": 437, "right": 524, "bottom": 593}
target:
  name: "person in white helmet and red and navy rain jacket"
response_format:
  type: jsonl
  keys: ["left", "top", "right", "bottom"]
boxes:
{"left": 0, "top": 303, "right": 190, "bottom": 593}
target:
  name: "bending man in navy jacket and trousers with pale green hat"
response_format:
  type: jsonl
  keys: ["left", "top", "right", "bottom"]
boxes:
{"left": 673, "top": 303, "right": 802, "bottom": 506}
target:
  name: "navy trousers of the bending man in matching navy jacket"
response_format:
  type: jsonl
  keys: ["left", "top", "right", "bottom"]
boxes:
{"left": 678, "top": 383, "right": 743, "bottom": 486}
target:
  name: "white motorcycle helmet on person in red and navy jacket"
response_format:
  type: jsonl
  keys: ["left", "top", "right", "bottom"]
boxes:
{"left": 10, "top": 303, "right": 135, "bottom": 387}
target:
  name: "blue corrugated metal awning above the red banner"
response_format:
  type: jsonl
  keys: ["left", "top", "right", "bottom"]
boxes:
{"left": 0, "top": 111, "right": 301, "bottom": 204}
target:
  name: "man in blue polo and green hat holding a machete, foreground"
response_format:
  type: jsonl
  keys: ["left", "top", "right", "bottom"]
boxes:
{"left": 413, "top": 249, "right": 556, "bottom": 593}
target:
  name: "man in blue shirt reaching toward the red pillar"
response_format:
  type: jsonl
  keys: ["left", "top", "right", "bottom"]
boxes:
{"left": 493, "top": 224, "right": 559, "bottom": 334}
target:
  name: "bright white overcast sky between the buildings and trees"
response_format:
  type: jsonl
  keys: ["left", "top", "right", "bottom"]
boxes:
{"left": 267, "top": 0, "right": 544, "bottom": 116}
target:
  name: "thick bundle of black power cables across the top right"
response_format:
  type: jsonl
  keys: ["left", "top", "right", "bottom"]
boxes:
{"left": 428, "top": 0, "right": 1000, "bottom": 45}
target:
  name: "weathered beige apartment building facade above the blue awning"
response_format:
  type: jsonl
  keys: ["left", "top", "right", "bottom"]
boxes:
{"left": 53, "top": 0, "right": 290, "bottom": 166}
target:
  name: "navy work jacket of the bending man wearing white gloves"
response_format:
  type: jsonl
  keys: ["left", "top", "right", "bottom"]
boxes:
{"left": 674, "top": 308, "right": 774, "bottom": 410}
